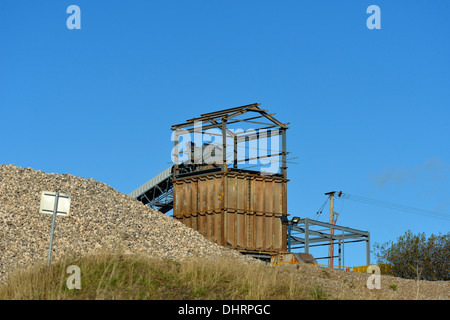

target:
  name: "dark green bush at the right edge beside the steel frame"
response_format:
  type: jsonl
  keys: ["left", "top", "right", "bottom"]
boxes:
{"left": 374, "top": 230, "right": 450, "bottom": 280}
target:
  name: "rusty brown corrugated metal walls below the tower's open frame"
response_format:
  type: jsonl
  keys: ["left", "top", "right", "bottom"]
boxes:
{"left": 173, "top": 173, "right": 287, "bottom": 252}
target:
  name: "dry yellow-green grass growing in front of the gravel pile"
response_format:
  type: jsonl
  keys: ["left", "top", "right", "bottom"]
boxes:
{"left": 0, "top": 254, "right": 327, "bottom": 300}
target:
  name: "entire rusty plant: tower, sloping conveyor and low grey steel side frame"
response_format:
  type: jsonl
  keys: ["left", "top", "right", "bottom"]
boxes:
{"left": 129, "top": 103, "right": 370, "bottom": 267}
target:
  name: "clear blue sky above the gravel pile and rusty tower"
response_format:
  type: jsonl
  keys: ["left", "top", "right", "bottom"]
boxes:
{"left": 0, "top": 0, "right": 450, "bottom": 265}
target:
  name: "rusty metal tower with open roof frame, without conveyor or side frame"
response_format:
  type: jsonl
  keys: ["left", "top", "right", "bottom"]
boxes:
{"left": 172, "top": 104, "right": 288, "bottom": 258}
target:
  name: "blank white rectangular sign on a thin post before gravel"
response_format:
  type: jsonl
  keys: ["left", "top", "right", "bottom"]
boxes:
{"left": 39, "top": 191, "right": 71, "bottom": 267}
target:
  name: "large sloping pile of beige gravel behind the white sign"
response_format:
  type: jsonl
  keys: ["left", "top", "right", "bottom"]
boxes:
{"left": 0, "top": 165, "right": 254, "bottom": 282}
